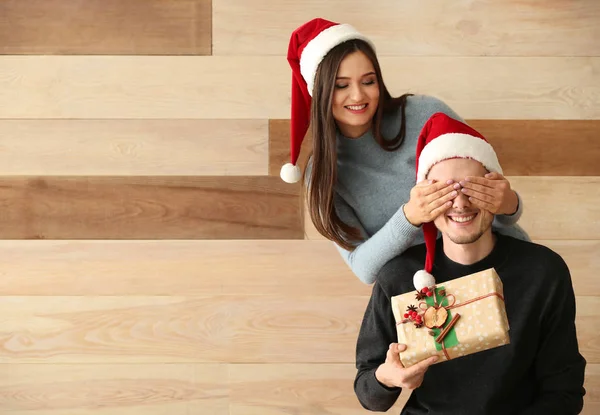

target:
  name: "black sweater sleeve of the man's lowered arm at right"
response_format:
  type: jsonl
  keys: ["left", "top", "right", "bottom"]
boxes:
{"left": 521, "top": 260, "right": 586, "bottom": 415}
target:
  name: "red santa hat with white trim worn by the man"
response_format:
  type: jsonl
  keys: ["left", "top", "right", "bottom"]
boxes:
{"left": 413, "top": 112, "right": 502, "bottom": 291}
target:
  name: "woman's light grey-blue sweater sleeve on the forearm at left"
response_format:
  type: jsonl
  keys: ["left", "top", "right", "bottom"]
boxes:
{"left": 335, "top": 196, "right": 421, "bottom": 284}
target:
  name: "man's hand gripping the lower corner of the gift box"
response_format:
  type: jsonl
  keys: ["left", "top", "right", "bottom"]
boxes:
{"left": 375, "top": 343, "right": 438, "bottom": 390}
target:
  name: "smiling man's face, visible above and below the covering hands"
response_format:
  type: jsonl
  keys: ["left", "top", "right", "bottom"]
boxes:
{"left": 427, "top": 158, "right": 494, "bottom": 244}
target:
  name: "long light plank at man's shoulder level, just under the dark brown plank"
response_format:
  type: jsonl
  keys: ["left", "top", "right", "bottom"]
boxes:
{"left": 0, "top": 240, "right": 600, "bottom": 297}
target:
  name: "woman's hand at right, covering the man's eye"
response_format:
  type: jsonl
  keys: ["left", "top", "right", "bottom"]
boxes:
{"left": 460, "top": 172, "right": 519, "bottom": 215}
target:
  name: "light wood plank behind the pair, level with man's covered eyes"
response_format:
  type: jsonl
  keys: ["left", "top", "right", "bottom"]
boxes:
{"left": 304, "top": 176, "right": 600, "bottom": 240}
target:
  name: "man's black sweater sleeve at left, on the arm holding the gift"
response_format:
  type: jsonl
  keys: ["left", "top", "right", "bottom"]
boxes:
{"left": 354, "top": 283, "right": 402, "bottom": 412}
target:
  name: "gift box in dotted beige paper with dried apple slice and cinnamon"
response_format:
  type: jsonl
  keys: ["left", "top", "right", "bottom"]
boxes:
{"left": 391, "top": 268, "right": 510, "bottom": 367}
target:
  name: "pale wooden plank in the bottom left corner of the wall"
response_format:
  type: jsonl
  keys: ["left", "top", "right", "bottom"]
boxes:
{"left": 0, "top": 363, "right": 229, "bottom": 415}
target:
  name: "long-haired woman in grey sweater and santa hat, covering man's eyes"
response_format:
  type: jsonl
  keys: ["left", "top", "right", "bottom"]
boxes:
{"left": 281, "top": 19, "right": 529, "bottom": 284}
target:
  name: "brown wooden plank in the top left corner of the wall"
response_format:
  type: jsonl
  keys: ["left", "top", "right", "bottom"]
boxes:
{"left": 0, "top": 0, "right": 212, "bottom": 55}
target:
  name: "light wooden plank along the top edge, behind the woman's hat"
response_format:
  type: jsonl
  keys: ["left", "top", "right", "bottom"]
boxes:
{"left": 213, "top": 0, "right": 600, "bottom": 56}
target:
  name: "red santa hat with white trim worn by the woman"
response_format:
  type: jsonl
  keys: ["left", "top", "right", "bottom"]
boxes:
{"left": 280, "top": 18, "right": 375, "bottom": 183}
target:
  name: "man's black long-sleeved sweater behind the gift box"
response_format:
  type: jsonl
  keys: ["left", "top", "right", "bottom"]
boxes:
{"left": 354, "top": 234, "right": 586, "bottom": 415}
